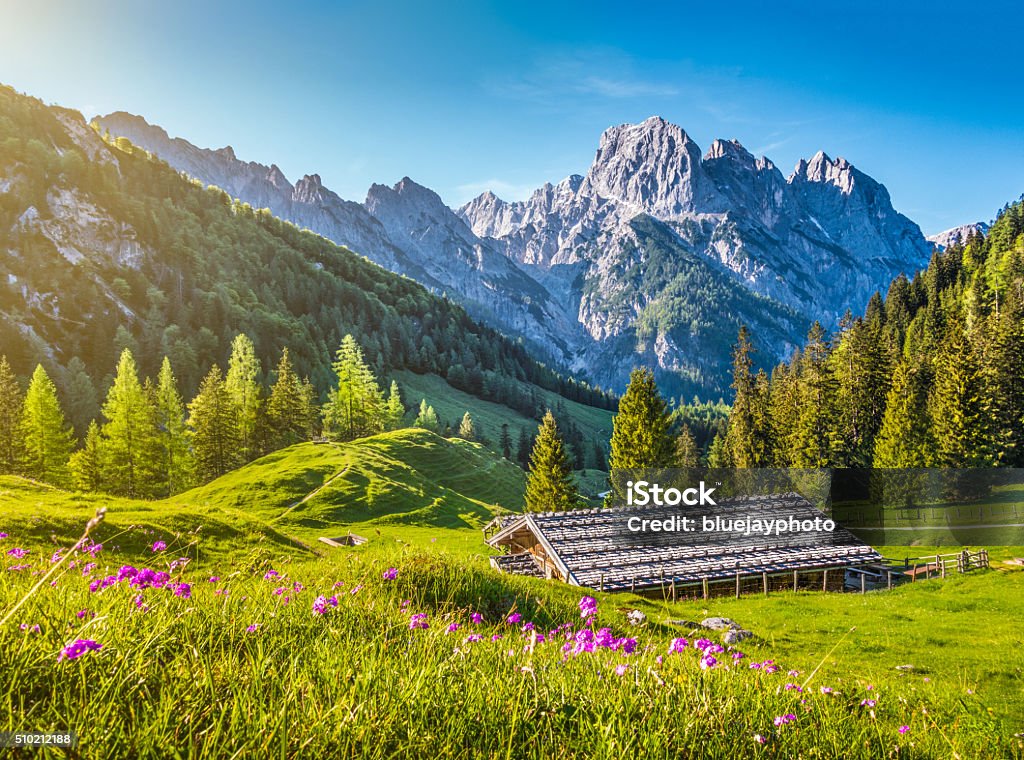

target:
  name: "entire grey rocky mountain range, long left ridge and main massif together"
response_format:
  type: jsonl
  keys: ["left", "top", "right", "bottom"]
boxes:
{"left": 96, "top": 113, "right": 932, "bottom": 395}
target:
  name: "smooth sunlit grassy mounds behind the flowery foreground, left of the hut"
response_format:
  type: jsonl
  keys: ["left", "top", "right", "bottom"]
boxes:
{"left": 0, "top": 429, "right": 525, "bottom": 554}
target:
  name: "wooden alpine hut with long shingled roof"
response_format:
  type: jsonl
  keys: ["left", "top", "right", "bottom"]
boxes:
{"left": 483, "top": 494, "right": 882, "bottom": 597}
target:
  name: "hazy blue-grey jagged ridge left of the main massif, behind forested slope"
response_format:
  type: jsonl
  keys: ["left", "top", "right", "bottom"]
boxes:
{"left": 95, "top": 112, "right": 579, "bottom": 364}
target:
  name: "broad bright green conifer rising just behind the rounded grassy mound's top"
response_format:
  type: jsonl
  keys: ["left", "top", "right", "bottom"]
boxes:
{"left": 324, "top": 335, "right": 384, "bottom": 440}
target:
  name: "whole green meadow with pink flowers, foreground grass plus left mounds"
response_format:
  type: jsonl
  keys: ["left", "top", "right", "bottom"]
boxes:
{"left": 0, "top": 430, "right": 1024, "bottom": 758}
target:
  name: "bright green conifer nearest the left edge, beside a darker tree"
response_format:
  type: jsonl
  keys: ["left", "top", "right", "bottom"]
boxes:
{"left": 20, "top": 365, "right": 74, "bottom": 485}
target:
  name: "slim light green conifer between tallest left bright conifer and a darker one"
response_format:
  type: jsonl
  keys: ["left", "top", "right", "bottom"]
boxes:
{"left": 153, "top": 356, "right": 193, "bottom": 496}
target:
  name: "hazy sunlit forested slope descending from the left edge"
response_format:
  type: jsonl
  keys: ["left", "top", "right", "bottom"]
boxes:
{"left": 0, "top": 87, "right": 614, "bottom": 415}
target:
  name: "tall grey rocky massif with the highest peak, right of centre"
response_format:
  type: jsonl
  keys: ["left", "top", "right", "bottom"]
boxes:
{"left": 459, "top": 118, "right": 931, "bottom": 390}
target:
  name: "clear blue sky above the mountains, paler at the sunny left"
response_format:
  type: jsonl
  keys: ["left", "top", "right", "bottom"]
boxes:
{"left": 0, "top": 0, "right": 1024, "bottom": 234}
